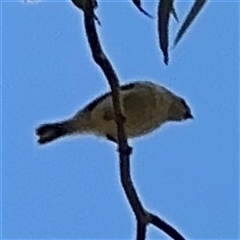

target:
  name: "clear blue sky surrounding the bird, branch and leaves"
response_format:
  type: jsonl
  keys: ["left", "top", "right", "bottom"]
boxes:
{"left": 1, "top": 0, "right": 239, "bottom": 239}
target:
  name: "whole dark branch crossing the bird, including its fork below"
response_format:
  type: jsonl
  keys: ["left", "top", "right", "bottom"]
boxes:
{"left": 76, "top": 0, "right": 187, "bottom": 240}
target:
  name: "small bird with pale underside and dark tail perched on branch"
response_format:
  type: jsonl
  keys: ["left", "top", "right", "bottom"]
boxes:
{"left": 36, "top": 81, "right": 193, "bottom": 144}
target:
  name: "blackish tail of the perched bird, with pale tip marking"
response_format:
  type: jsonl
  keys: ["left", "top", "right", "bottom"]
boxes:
{"left": 36, "top": 123, "right": 68, "bottom": 144}
